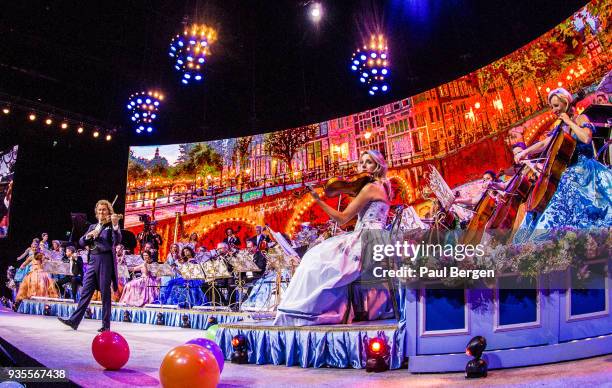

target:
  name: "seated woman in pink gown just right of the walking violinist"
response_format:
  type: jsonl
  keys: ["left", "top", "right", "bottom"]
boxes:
{"left": 119, "top": 251, "right": 159, "bottom": 307}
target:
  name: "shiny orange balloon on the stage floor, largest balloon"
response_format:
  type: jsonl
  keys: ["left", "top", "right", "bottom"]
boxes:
{"left": 159, "top": 344, "right": 220, "bottom": 388}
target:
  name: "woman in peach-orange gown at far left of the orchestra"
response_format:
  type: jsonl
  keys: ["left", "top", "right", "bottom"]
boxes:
{"left": 15, "top": 252, "right": 59, "bottom": 304}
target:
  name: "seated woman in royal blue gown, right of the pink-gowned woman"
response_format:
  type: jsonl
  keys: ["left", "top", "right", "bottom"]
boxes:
{"left": 160, "top": 247, "right": 207, "bottom": 307}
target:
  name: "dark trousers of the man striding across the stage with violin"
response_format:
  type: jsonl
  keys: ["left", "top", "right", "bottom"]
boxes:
{"left": 70, "top": 253, "right": 114, "bottom": 328}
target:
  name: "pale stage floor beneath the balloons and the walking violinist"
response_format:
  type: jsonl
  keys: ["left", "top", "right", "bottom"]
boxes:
{"left": 0, "top": 308, "right": 612, "bottom": 387}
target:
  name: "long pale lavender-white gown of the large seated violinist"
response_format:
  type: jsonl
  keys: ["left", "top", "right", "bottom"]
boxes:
{"left": 274, "top": 197, "right": 391, "bottom": 326}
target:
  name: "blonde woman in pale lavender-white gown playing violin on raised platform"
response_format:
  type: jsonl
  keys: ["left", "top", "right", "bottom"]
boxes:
{"left": 274, "top": 150, "right": 391, "bottom": 326}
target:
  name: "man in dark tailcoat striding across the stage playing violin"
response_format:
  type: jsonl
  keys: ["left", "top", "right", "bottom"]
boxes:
{"left": 58, "top": 199, "right": 121, "bottom": 332}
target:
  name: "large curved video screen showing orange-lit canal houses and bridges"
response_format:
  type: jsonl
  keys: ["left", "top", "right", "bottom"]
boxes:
{"left": 125, "top": 2, "right": 612, "bottom": 255}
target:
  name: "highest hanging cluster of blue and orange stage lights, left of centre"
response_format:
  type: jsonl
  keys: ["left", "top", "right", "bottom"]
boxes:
{"left": 168, "top": 24, "right": 217, "bottom": 85}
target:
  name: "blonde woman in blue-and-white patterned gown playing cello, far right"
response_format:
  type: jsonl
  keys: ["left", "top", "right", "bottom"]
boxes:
{"left": 514, "top": 88, "right": 612, "bottom": 243}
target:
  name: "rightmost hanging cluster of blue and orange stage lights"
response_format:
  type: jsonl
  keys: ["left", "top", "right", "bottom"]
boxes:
{"left": 351, "top": 35, "right": 389, "bottom": 96}
